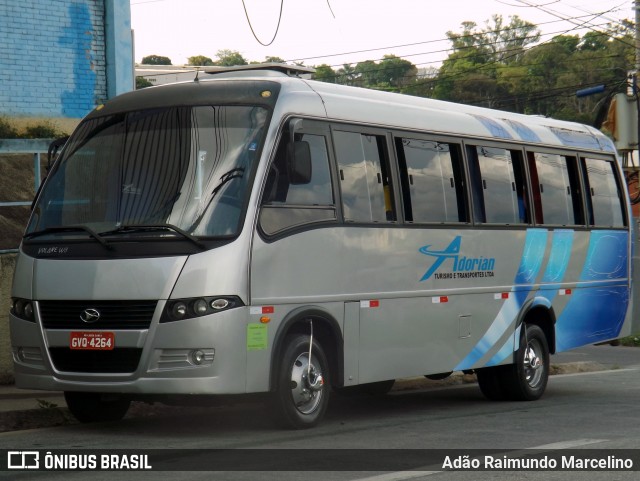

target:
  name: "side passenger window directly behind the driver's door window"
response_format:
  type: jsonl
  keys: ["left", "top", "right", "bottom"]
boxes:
{"left": 333, "top": 131, "right": 396, "bottom": 222}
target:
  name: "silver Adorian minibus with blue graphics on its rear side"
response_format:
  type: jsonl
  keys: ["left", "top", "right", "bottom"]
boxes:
{"left": 10, "top": 66, "right": 633, "bottom": 428}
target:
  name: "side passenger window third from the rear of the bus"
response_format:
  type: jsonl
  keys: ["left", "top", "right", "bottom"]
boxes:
{"left": 467, "top": 146, "right": 530, "bottom": 224}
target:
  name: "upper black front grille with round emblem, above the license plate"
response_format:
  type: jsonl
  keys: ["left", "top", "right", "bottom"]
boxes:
{"left": 38, "top": 301, "right": 158, "bottom": 330}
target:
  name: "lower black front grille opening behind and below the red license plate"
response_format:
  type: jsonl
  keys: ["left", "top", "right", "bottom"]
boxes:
{"left": 49, "top": 347, "right": 142, "bottom": 374}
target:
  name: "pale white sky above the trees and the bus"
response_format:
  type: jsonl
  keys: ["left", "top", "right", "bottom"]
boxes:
{"left": 130, "top": 0, "right": 635, "bottom": 69}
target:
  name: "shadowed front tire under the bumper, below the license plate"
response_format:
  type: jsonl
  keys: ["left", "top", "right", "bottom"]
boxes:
{"left": 64, "top": 391, "right": 131, "bottom": 423}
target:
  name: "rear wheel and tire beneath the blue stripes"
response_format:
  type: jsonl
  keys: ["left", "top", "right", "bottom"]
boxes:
{"left": 501, "top": 324, "right": 549, "bottom": 401}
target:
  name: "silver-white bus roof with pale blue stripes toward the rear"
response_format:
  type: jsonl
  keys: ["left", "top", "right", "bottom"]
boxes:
{"left": 99, "top": 65, "right": 616, "bottom": 153}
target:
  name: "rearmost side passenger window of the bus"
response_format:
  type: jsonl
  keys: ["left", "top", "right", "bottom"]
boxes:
{"left": 581, "top": 158, "right": 625, "bottom": 227}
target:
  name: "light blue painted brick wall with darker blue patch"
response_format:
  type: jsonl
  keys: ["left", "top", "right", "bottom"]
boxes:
{"left": 0, "top": 0, "right": 133, "bottom": 118}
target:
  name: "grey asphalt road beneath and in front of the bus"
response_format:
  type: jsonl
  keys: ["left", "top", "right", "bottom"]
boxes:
{"left": 0, "top": 346, "right": 640, "bottom": 481}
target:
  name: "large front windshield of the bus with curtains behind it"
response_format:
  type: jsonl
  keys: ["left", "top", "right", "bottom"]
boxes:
{"left": 26, "top": 106, "right": 267, "bottom": 238}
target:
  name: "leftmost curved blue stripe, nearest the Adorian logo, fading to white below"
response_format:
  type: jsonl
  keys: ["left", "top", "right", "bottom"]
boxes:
{"left": 454, "top": 229, "right": 549, "bottom": 371}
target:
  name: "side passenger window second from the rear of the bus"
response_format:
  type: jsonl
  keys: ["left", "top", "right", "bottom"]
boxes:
{"left": 528, "top": 152, "right": 584, "bottom": 225}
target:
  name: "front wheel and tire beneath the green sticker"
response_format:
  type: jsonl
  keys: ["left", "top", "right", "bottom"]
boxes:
{"left": 272, "top": 335, "right": 331, "bottom": 429}
